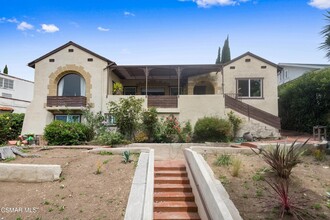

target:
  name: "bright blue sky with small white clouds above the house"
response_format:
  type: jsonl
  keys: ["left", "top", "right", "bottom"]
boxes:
{"left": 0, "top": 0, "right": 330, "bottom": 80}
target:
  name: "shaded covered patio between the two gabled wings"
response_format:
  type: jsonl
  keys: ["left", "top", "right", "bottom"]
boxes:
{"left": 108, "top": 64, "right": 222, "bottom": 108}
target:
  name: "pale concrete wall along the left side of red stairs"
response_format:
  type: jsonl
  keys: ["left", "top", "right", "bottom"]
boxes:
{"left": 125, "top": 148, "right": 154, "bottom": 220}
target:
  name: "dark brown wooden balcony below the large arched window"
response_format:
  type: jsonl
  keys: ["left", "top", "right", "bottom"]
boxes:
{"left": 47, "top": 96, "right": 87, "bottom": 107}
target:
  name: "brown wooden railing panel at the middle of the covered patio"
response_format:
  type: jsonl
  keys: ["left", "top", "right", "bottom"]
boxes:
{"left": 148, "top": 95, "right": 178, "bottom": 108}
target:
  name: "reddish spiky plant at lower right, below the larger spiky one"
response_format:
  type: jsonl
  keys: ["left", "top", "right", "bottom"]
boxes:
{"left": 265, "top": 178, "right": 315, "bottom": 220}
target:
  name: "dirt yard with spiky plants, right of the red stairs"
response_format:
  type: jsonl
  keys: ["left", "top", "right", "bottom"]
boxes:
{"left": 204, "top": 151, "right": 330, "bottom": 220}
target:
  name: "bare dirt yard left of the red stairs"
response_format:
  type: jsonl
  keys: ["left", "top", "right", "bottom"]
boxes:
{"left": 0, "top": 149, "right": 138, "bottom": 220}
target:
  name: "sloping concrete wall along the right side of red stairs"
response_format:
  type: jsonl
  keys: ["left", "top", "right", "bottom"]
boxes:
{"left": 184, "top": 149, "right": 242, "bottom": 220}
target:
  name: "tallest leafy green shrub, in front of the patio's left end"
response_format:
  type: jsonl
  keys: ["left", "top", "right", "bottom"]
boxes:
{"left": 108, "top": 96, "right": 143, "bottom": 140}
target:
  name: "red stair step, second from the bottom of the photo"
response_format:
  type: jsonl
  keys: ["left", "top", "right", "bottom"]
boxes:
{"left": 154, "top": 201, "right": 197, "bottom": 212}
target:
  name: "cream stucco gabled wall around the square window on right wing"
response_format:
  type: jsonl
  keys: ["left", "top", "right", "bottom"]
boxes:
{"left": 223, "top": 55, "right": 278, "bottom": 116}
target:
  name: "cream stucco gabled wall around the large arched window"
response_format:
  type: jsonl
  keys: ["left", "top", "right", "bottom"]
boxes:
{"left": 22, "top": 45, "right": 107, "bottom": 134}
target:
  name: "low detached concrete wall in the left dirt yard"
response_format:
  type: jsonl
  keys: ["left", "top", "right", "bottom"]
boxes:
{"left": 0, "top": 163, "right": 62, "bottom": 182}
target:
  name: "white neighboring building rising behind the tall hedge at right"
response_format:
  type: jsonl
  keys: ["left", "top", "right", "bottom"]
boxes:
{"left": 277, "top": 63, "right": 330, "bottom": 85}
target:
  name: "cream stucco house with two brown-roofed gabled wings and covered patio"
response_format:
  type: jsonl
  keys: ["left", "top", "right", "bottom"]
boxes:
{"left": 22, "top": 42, "right": 280, "bottom": 136}
